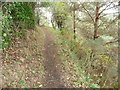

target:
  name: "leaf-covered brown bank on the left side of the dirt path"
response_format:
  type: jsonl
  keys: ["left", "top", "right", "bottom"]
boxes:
{"left": 2, "top": 27, "right": 45, "bottom": 88}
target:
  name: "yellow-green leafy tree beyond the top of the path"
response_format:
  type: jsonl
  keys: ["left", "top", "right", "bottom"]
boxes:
{"left": 52, "top": 2, "right": 69, "bottom": 30}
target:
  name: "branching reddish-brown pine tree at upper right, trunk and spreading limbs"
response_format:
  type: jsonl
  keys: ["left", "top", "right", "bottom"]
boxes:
{"left": 81, "top": 2, "right": 117, "bottom": 40}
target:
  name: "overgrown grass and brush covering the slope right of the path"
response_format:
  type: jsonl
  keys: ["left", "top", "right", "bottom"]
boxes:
{"left": 58, "top": 30, "right": 118, "bottom": 88}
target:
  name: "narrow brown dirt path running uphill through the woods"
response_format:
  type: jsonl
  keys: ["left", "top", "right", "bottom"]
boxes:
{"left": 43, "top": 28, "right": 64, "bottom": 88}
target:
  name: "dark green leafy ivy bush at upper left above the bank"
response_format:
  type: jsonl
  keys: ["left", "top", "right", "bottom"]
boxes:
{"left": 0, "top": 2, "right": 35, "bottom": 49}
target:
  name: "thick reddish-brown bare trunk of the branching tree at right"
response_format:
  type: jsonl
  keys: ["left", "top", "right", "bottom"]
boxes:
{"left": 93, "top": 2, "right": 100, "bottom": 40}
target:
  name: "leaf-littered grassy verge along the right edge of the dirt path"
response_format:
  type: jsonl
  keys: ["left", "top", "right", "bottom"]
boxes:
{"left": 53, "top": 30, "right": 99, "bottom": 88}
